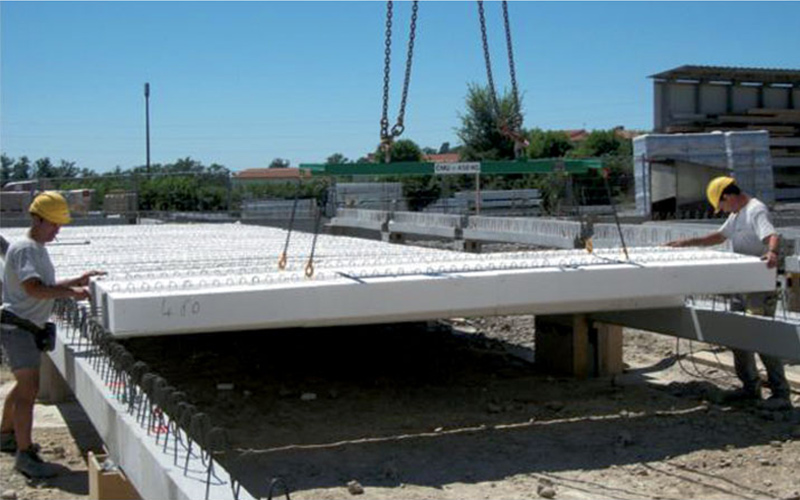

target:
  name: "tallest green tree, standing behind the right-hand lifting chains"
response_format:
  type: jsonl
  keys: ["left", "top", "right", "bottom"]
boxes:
{"left": 456, "top": 84, "right": 522, "bottom": 161}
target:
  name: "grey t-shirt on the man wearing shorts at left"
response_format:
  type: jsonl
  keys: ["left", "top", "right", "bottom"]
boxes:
{"left": 3, "top": 236, "right": 56, "bottom": 328}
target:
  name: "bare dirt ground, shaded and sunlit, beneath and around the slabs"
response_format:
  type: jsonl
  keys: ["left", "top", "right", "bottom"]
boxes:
{"left": 0, "top": 316, "right": 800, "bottom": 500}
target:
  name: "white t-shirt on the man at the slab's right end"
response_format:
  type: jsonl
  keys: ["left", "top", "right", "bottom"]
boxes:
{"left": 719, "top": 198, "right": 775, "bottom": 257}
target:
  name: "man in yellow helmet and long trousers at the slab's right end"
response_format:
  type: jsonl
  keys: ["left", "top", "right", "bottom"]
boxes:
{"left": 667, "top": 176, "right": 792, "bottom": 410}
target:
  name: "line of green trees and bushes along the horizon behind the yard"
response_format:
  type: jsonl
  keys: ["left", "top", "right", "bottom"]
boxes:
{"left": 0, "top": 85, "right": 632, "bottom": 211}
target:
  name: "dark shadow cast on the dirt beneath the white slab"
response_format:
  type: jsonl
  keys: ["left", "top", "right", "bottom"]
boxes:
{"left": 126, "top": 324, "right": 792, "bottom": 496}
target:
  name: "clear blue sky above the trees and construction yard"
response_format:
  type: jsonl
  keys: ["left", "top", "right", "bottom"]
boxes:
{"left": 0, "top": 1, "right": 800, "bottom": 172}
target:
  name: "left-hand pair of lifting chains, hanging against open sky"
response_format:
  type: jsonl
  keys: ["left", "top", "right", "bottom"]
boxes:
{"left": 380, "top": 0, "right": 419, "bottom": 163}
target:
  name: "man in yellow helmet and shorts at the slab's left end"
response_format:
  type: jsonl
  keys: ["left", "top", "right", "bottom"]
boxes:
{"left": 0, "top": 191, "right": 104, "bottom": 478}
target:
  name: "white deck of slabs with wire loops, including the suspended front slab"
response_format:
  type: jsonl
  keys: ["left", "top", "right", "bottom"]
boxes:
{"left": 0, "top": 224, "right": 775, "bottom": 337}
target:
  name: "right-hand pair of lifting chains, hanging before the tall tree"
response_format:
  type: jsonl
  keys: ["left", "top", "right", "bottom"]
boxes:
{"left": 478, "top": 0, "right": 528, "bottom": 157}
